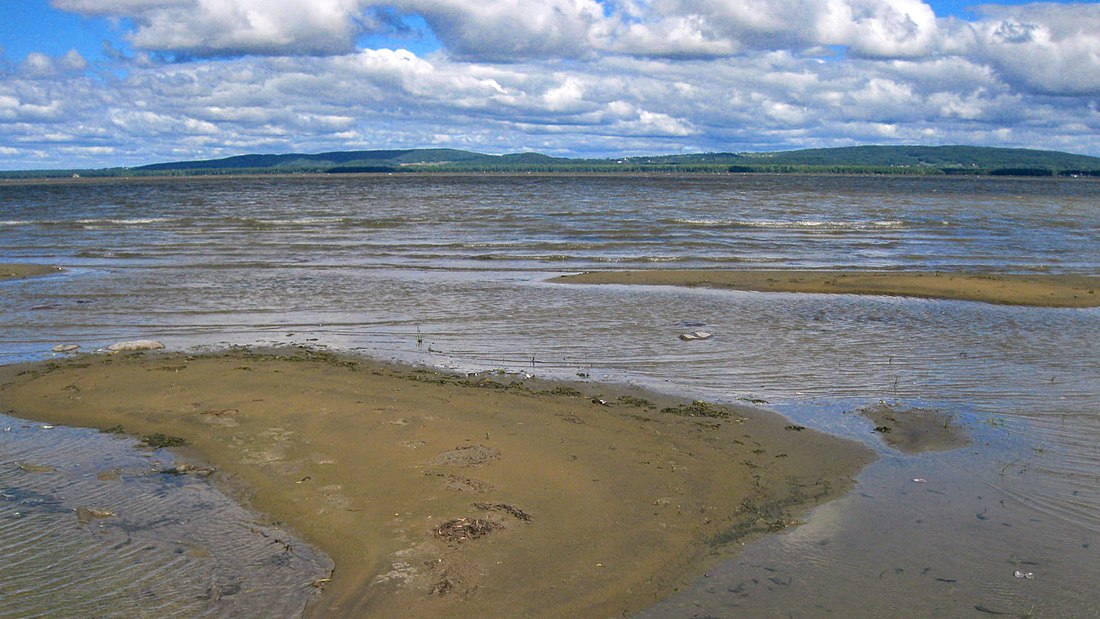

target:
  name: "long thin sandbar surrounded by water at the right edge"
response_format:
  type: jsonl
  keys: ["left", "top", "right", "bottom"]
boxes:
{"left": 554, "top": 270, "right": 1100, "bottom": 308}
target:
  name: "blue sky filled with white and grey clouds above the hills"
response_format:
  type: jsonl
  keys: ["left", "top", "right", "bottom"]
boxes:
{"left": 0, "top": 0, "right": 1100, "bottom": 169}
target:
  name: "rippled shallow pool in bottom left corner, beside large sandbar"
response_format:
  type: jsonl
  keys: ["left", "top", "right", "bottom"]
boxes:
{"left": 0, "top": 414, "right": 332, "bottom": 618}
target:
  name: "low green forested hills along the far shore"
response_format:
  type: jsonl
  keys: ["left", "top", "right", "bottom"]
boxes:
{"left": 0, "top": 146, "right": 1100, "bottom": 178}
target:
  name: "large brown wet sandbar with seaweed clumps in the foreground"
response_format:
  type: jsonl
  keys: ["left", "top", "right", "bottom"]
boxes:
{"left": 0, "top": 350, "right": 873, "bottom": 617}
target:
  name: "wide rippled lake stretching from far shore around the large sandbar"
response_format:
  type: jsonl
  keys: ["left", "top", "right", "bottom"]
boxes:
{"left": 0, "top": 175, "right": 1100, "bottom": 617}
